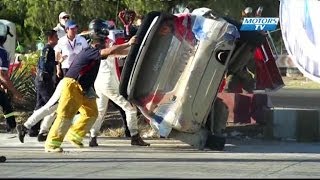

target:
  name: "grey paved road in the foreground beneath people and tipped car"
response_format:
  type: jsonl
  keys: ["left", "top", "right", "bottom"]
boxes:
{"left": 0, "top": 134, "right": 320, "bottom": 179}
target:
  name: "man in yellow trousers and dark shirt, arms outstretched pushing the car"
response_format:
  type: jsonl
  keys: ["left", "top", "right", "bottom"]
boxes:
{"left": 44, "top": 19, "right": 136, "bottom": 152}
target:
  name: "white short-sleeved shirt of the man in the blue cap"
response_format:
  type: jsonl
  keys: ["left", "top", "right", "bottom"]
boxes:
{"left": 54, "top": 35, "right": 89, "bottom": 68}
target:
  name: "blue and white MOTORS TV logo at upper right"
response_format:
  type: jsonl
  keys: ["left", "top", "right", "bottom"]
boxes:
{"left": 240, "top": 17, "right": 279, "bottom": 31}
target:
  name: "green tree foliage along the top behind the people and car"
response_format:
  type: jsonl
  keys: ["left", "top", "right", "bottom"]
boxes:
{"left": 0, "top": 0, "right": 281, "bottom": 50}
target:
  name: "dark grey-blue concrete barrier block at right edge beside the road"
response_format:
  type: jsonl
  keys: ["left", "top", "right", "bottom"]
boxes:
{"left": 264, "top": 108, "right": 320, "bottom": 142}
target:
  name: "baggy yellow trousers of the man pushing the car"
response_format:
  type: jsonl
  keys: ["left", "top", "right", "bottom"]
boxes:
{"left": 45, "top": 77, "right": 98, "bottom": 148}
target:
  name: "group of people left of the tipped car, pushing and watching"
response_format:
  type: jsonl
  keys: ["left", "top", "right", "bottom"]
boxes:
{"left": 0, "top": 12, "right": 150, "bottom": 152}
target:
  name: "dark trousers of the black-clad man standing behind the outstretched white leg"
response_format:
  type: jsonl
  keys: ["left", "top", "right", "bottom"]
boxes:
{"left": 29, "top": 79, "right": 55, "bottom": 136}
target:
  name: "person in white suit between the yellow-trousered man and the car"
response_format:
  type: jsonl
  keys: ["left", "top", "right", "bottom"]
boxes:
{"left": 89, "top": 27, "right": 150, "bottom": 147}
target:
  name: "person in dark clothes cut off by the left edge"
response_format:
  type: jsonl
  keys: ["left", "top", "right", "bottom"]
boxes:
{"left": 0, "top": 22, "right": 23, "bottom": 132}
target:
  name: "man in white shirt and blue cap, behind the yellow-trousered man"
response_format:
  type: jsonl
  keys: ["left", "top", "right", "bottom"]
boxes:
{"left": 54, "top": 20, "right": 89, "bottom": 78}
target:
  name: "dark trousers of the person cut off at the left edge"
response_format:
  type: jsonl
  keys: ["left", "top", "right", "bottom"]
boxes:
{"left": 0, "top": 90, "right": 17, "bottom": 132}
